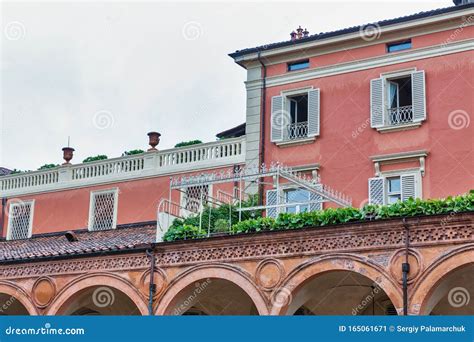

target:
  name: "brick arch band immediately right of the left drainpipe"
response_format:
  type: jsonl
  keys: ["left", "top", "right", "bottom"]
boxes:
{"left": 155, "top": 264, "right": 268, "bottom": 315}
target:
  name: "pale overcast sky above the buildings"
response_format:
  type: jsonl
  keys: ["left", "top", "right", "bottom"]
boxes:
{"left": 0, "top": 0, "right": 452, "bottom": 170}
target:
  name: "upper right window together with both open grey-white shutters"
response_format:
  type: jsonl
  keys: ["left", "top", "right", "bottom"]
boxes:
{"left": 370, "top": 69, "right": 426, "bottom": 130}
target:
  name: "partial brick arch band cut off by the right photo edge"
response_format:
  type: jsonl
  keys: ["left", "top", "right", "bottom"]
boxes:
{"left": 410, "top": 244, "right": 474, "bottom": 315}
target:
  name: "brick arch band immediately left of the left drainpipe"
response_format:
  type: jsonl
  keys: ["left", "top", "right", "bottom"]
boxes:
{"left": 45, "top": 273, "right": 148, "bottom": 315}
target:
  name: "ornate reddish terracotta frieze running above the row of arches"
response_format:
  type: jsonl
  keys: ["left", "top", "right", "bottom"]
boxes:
{"left": 0, "top": 213, "right": 474, "bottom": 279}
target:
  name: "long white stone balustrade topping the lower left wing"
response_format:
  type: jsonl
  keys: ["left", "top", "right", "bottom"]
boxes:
{"left": 0, "top": 136, "right": 245, "bottom": 197}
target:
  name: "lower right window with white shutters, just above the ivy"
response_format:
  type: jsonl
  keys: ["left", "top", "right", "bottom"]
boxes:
{"left": 369, "top": 171, "right": 422, "bottom": 204}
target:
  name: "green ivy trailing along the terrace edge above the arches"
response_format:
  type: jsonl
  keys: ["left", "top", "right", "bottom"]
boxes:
{"left": 164, "top": 190, "right": 474, "bottom": 241}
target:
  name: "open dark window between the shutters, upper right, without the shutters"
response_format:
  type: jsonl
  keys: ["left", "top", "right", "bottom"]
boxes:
{"left": 386, "top": 76, "right": 413, "bottom": 125}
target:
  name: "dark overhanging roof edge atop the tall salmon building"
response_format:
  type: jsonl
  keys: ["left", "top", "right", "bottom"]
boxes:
{"left": 229, "top": 3, "right": 474, "bottom": 58}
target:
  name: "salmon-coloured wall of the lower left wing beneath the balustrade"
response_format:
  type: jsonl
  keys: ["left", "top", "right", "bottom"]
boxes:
{"left": 0, "top": 168, "right": 237, "bottom": 237}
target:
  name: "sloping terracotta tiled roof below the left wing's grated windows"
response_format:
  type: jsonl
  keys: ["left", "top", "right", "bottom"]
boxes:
{"left": 0, "top": 223, "right": 156, "bottom": 262}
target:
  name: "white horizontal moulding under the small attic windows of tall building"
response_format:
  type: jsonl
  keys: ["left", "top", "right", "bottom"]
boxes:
{"left": 246, "top": 39, "right": 474, "bottom": 90}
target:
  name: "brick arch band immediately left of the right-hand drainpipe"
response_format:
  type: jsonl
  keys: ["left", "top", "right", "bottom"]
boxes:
{"left": 270, "top": 254, "right": 403, "bottom": 315}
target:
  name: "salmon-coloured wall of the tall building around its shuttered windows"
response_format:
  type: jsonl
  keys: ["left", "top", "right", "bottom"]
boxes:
{"left": 265, "top": 51, "right": 474, "bottom": 206}
